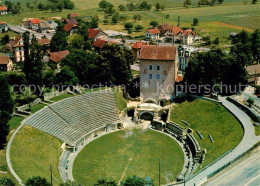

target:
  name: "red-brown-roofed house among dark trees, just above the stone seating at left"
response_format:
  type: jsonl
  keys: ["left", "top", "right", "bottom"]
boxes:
{"left": 48, "top": 50, "right": 70, "bottom": 70}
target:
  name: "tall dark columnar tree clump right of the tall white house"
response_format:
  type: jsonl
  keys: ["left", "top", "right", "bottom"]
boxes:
{"left": 23, "top": 31, "right": 43, "bottom": 95}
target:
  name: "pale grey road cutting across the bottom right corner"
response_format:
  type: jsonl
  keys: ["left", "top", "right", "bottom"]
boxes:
{"left": 205, "top": 151, "right": 260, "bottom": 186}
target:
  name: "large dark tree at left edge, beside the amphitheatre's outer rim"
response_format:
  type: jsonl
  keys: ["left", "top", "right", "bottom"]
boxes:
{"left": 0, "top": 74, "right": 14, "bottom": 149}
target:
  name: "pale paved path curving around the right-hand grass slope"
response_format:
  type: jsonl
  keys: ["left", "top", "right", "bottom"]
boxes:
{"left": 171, "top": 97, "right": 260, "bottom": 186}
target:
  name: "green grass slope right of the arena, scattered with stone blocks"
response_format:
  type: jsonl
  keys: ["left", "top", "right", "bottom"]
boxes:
{"left": 171, "top": 99, "right": 243, "bottom": 167}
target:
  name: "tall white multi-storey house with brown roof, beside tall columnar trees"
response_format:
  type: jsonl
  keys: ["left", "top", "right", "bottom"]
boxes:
{"left": 6, "top": 35, "right": 24, "bottom": 62}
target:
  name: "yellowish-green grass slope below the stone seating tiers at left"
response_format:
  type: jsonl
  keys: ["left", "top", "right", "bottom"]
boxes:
{"left": 10, "top": 125, "right": 62, "bottom": 185}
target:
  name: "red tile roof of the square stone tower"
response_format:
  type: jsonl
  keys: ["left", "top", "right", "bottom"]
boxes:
{"left": 139, "top": 45, "right": 176, "bottom": 60}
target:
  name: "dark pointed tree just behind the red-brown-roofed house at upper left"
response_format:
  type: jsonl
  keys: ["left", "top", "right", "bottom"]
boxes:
{"left": 50, "top": 22, "right": 68, "bottom": 52}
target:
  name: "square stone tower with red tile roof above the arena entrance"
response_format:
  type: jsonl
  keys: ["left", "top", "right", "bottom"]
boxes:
{"left": 139, "top": 45, "right": 178, "bottom": 100}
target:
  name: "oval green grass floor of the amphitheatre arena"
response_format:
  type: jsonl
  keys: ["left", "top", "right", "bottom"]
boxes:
{"left": 73, "top": 129, "right": 184, "bottom": 185}
